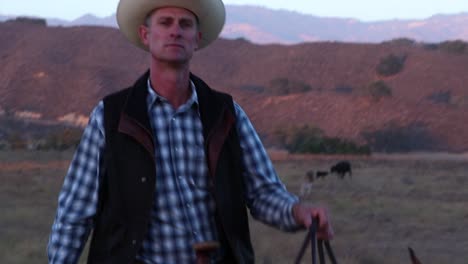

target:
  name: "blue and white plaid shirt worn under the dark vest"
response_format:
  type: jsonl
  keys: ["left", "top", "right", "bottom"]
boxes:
{"left": 48, "top": 81, "right": 298, "bottom": 263}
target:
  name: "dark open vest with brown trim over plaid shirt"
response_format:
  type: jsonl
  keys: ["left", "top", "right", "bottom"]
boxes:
{"left": 88, "top": 72, "right": 254, "bottom": 264}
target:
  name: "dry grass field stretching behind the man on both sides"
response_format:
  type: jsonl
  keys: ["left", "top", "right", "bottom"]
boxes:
{"left": 0, "top": 151, "right": 468, "bottom": 264}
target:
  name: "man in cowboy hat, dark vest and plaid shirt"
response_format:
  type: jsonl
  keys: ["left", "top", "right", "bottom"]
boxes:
{"left": 48, "top": 0, "right": 332, "bottom": 263}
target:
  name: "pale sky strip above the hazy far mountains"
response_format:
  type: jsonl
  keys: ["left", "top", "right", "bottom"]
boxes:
{"left": 0, "top": 0, "right": 468, "bottom": 21}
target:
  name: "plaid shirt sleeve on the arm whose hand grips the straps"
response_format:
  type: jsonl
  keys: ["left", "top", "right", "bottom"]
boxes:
{"left": 234, "top": 102, "right": 299, "bottom": 231}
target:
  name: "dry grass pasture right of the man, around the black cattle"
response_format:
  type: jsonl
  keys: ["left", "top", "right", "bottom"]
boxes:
{"left": 252, "top": 154, "right": 468, "bottom": 264}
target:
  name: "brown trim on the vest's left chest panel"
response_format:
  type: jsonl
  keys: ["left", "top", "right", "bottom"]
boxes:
{"left": 118, "top": 113, "right": 154, "bottom": 157}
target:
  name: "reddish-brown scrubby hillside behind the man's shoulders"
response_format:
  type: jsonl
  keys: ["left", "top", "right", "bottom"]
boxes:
{"left": 0, "top": 20, "right": 468, "bottom": 151}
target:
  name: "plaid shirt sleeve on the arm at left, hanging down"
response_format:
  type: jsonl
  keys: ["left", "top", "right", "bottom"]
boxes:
{"left": 47, "top": 101, "right": 105, "bottom": 264}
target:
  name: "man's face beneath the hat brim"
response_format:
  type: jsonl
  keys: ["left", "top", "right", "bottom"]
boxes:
{"left": 140, "top": 7, "right": 201, "bottom": 64}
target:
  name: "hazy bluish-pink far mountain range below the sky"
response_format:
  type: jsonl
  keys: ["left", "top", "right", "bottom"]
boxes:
{"left": 0, "top": 5, "right": 468, "bottom": 44}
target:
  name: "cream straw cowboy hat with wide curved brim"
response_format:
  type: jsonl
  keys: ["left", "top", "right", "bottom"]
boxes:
{"left": 117, "top": 0, "right": 226, "bottom": 50}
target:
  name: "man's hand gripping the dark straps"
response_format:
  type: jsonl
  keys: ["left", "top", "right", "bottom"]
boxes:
{"left": 292, "top": 203, "right": 333, "bottom": 240}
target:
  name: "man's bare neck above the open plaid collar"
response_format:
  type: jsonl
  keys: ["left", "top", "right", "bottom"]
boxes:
{"left": 150, "top": 61, "right": 191, "bottom": 109}
